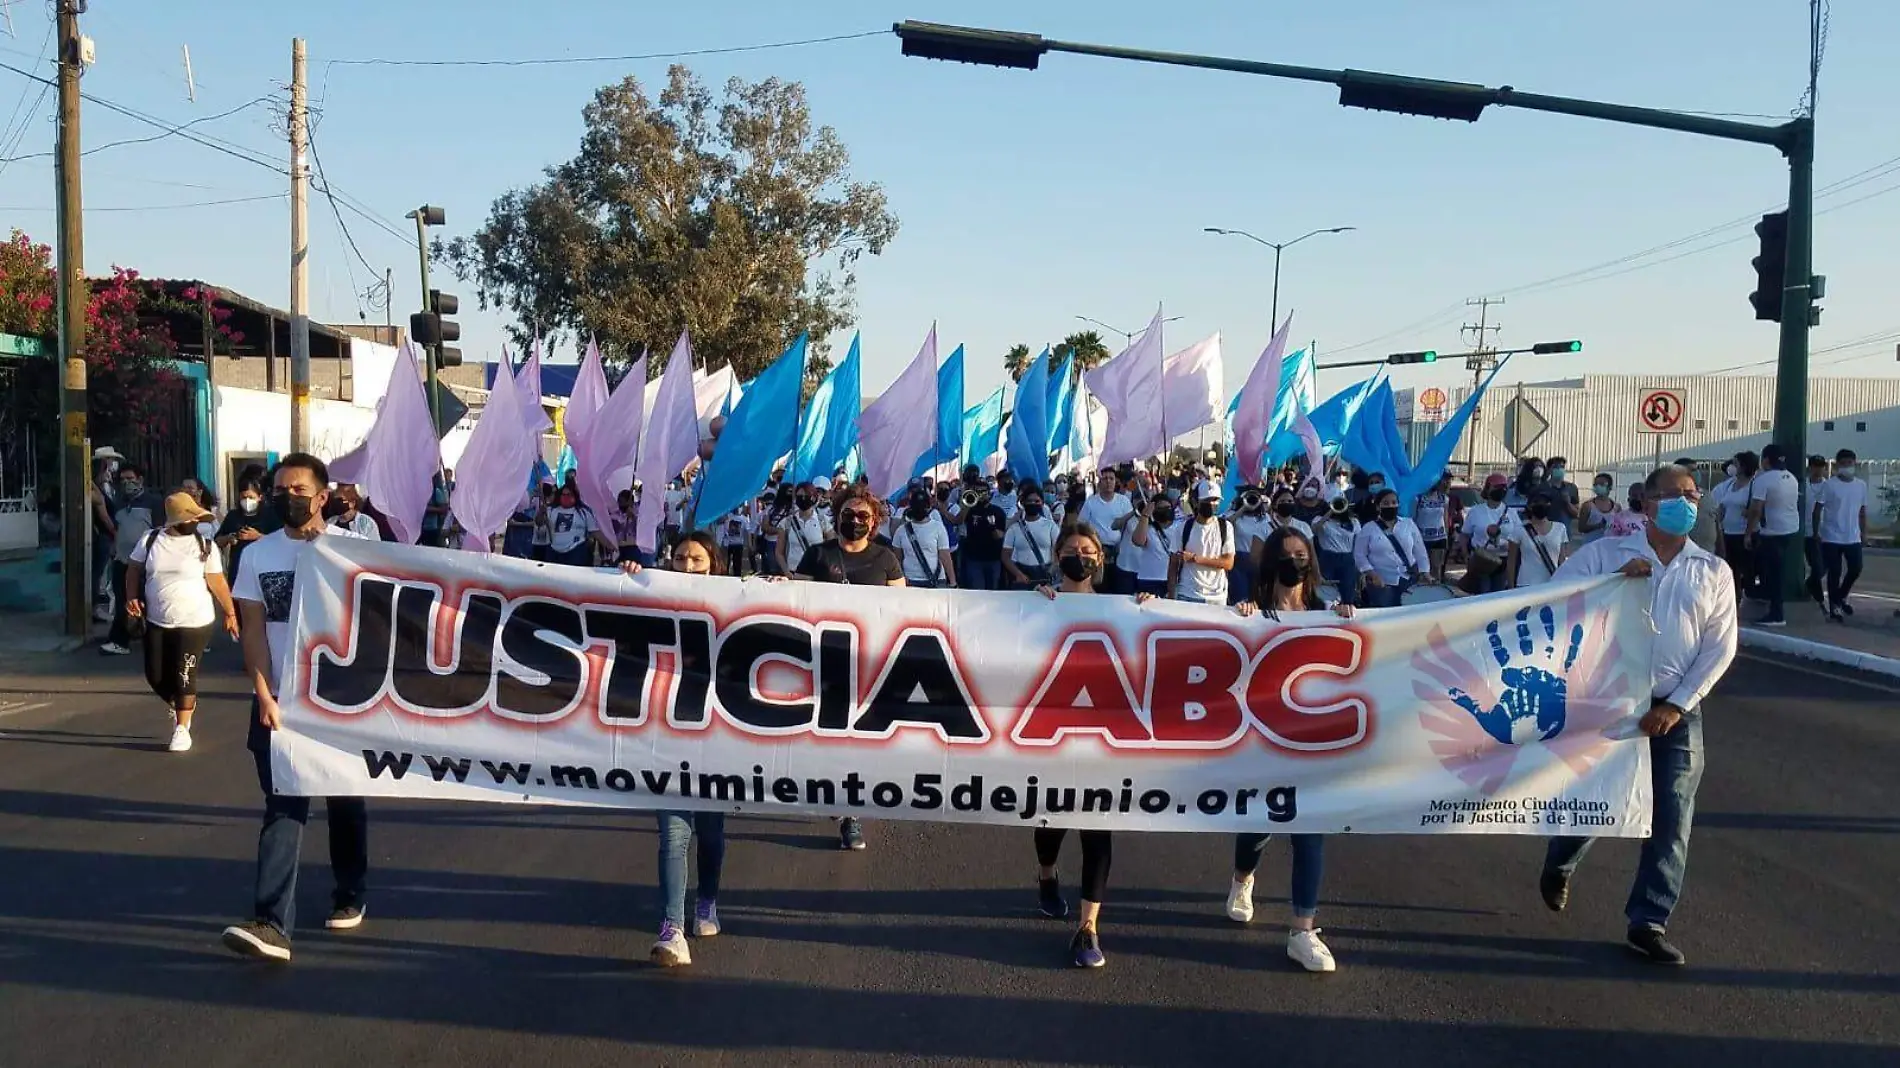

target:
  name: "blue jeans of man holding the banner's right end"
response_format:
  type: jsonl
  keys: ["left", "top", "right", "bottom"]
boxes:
{"left": 1545, "top": 709, "right": 1704, "bottom": 931}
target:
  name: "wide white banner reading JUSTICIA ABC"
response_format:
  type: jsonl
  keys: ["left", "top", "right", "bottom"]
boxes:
{"left": 272, "top": 538, "right": 1651, "bottom": 836}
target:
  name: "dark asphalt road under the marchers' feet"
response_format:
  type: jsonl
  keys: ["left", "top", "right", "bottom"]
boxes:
{"left": 0, "top": 638, "right": 1900, "bottom": 1068}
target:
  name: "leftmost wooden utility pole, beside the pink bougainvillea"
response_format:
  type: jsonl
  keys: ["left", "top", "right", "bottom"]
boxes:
{"left": 55, "top": 0, "right": 93, "bottom": 640}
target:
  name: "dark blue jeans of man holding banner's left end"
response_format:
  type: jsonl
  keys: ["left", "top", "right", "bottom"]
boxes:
{"left": 245, "top": 699, "right": 369, "bottom": 939}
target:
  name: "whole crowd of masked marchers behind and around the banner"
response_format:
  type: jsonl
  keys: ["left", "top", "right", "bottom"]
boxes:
{"left": 77, "top": 440, "right": 1793, "bottom": 971}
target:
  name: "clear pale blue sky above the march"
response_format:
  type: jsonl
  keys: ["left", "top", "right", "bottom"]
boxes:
{"left": 0, "top": 0, "right": 1900, "bottom": 403}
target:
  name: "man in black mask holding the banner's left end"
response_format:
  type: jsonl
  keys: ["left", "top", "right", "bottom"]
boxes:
{"left": 224, "top": 452, "right": 369, "bottom": 962}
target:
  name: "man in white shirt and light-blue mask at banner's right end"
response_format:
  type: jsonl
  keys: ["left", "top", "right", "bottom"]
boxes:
{"left": 1539, "top": 464, "right": 1737, "bottom": 965}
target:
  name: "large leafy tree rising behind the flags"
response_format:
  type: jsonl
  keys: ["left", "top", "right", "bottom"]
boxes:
{"left": 435, "top": 67, "right": 897, "bottom": 378}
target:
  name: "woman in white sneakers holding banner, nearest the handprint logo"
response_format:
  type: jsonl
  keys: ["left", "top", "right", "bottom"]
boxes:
{"left": 1227, "top": 526, "right": 1353, "bottom": 971}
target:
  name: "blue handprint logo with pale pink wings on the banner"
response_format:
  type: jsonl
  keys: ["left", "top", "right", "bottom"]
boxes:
{"left": 1412, "top": 593, "right": 1636, "bottom": 794}
